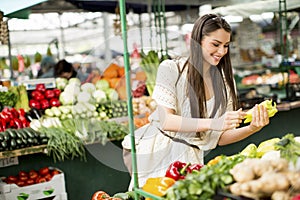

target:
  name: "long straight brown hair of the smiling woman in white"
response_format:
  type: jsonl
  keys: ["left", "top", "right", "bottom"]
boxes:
{"left": 179, "top": 14, "right": 238, "bottom": 118}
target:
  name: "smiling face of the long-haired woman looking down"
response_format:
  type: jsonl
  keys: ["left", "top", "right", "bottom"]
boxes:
{"left": 201, "top": 29, "right": 230, "bottom": 65}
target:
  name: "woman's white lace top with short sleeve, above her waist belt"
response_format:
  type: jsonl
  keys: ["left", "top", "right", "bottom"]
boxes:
{"left": 149, "top": 58, "right": 233, "bottom": 150}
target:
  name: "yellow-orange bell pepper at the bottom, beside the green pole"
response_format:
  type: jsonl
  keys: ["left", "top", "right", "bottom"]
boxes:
{"left": 142, "top": 177, "right": 175, "bottom": 200}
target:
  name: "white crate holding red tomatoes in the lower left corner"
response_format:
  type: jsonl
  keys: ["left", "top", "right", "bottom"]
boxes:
{"left": 0, "top": 167, "right": 67, "bottom": 200}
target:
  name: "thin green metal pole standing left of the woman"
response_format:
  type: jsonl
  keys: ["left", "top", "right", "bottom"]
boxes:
{"left": 119, "top": 0, "right": 139, "bottom": 200}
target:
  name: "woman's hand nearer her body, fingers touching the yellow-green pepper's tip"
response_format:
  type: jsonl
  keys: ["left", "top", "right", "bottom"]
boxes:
{"left": 210, "top": 109, "right": 246, "bottom": 131}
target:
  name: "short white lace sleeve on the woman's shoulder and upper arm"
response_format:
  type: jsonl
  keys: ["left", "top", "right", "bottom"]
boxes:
{"left": 152, "top": 60, "right": 178, "bottom": 111}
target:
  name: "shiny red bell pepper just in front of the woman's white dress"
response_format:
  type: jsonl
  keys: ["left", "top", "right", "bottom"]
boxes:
{"left": 165, "top": 161, "right": 202, "bottom": 181}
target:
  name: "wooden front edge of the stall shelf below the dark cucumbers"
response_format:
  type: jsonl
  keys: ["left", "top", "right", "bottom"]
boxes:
{"left": 0, "top": 144, "right": 47, "bottom": 158}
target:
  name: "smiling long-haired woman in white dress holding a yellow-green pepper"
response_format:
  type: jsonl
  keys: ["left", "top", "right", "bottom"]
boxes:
{"left": 122, "top": 14, "right": 269, "bottom": 187}
